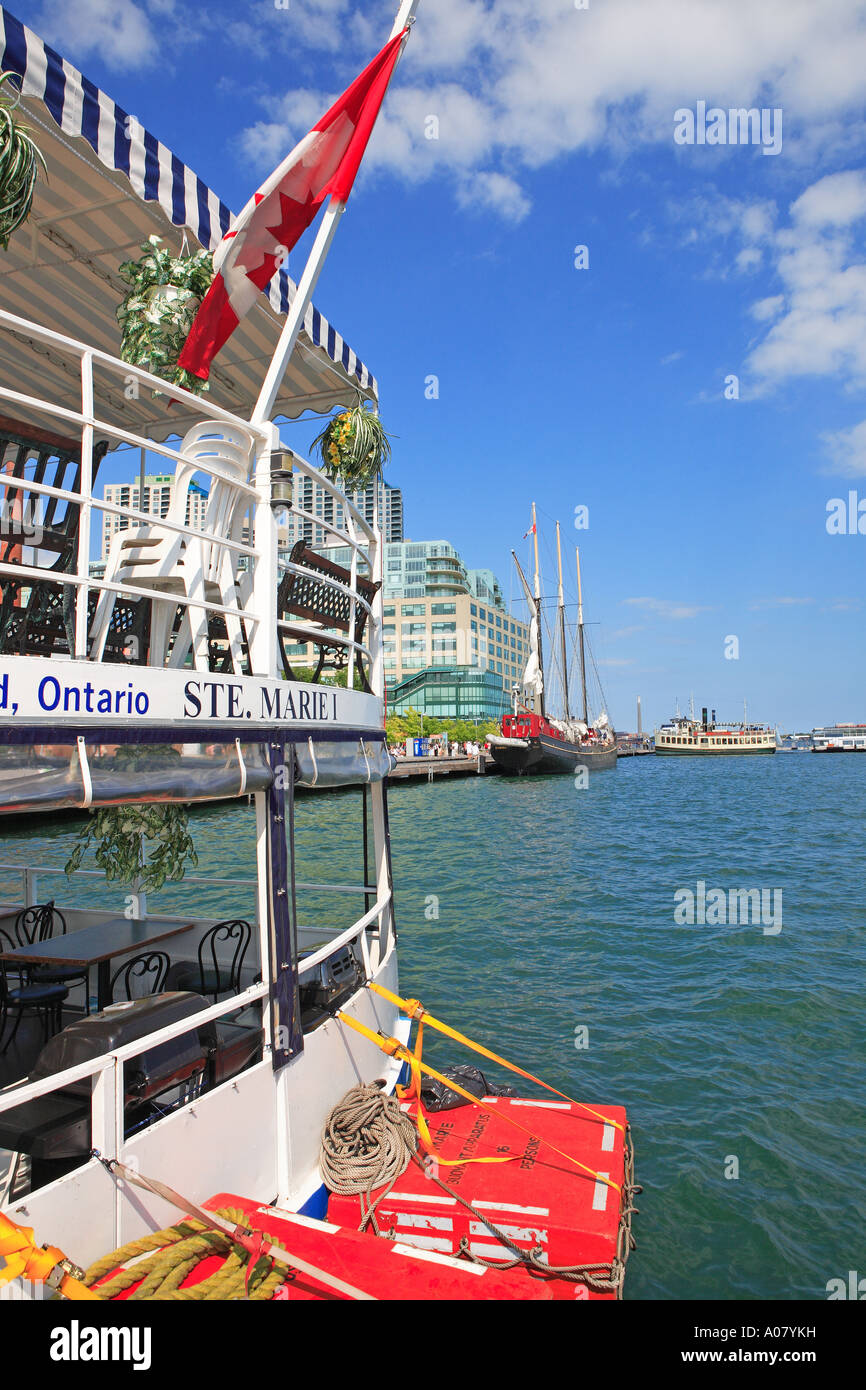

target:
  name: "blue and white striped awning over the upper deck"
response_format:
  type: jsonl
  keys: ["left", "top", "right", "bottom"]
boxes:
{"left": 0, "top": 7, "right": 378, "bottom": 430}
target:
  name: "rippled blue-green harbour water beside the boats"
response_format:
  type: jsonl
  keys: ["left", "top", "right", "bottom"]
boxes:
{"left": 3, "top": 756, "right": 866, "bottom": 1300}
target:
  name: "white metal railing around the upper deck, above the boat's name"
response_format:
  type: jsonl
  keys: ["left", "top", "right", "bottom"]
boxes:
{"left": 0, "top": 310, "right": 382, "bottom": 694}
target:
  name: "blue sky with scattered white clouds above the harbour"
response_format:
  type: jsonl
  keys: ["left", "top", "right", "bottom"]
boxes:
{"left": 10, "top": 0, "right": 866, "bottom": 730}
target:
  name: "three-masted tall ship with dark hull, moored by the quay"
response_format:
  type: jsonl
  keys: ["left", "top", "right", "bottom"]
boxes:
{"left": 488, "top": 503, "right": 617, "bottom": 776}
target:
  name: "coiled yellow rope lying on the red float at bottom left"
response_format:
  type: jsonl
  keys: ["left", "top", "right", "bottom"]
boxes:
{"left": 85, "top": 1207, "right": 289, "bottom": 1301}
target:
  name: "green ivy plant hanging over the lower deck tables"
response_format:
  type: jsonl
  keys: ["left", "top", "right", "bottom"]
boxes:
{"left": 65, "top": 746, "right": 199, "bottom": 892}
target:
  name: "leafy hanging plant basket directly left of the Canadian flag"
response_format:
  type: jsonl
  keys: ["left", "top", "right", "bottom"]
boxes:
{"left": 117, "top": 236, "right": 214, "bottom": 395}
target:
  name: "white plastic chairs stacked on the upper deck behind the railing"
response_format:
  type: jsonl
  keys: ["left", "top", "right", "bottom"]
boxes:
{"left": 90, "top": 421, "right": 254, "bottom": 671}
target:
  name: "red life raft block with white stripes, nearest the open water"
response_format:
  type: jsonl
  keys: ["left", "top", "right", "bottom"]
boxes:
{"left": 328, "top": 1095, "right": 635, "bottom": 1300}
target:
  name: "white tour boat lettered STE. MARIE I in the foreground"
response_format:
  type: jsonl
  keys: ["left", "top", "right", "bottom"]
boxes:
{"left": 0, "top": 0, "right": 637, "bottom": 1301}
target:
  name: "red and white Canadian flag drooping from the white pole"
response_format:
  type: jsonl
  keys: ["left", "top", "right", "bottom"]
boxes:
{"left": 178, "top": 29, "right": 409, "bottom": 381}
